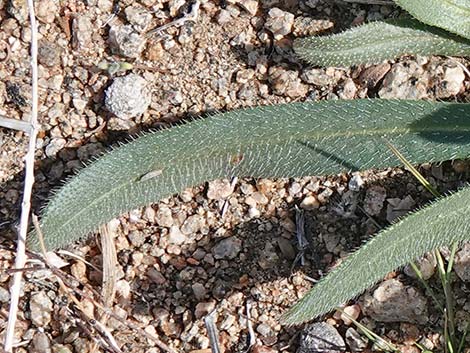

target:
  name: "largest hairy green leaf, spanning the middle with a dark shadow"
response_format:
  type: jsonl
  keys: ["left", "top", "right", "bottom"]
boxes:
{"left": 29, "top": 100, "right": 470, "bottom": 249}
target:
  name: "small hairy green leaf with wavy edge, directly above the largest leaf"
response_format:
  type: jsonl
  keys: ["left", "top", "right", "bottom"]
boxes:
{"left": 294, "top": 19, "right": 470, "bottom": 66}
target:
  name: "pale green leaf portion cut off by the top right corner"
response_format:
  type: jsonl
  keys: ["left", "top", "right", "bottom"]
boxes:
{"left": 395, "top": 0, "right": 470, "bottom": 39}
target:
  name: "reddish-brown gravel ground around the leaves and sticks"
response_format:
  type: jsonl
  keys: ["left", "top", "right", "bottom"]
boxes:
{"left": 0, "top": 0, "right": 470, "bottom": 353}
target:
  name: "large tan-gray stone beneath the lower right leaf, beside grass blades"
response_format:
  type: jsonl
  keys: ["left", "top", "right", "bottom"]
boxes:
{"left": 362, "top": 279, "right": 428, "bottom": 324}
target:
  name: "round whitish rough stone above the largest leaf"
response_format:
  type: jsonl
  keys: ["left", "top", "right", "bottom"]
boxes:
{"left": 105, "top": 74, "right": 151, "bottom": 119}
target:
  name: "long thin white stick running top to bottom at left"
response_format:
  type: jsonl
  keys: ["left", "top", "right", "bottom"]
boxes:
{"left": 4, "top": 0, "right": 38, "bottom": 353}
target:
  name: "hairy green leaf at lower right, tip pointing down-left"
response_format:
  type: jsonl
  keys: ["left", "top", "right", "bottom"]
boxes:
{"left": 282, "top": 187, "right": 470, "bottom": 325}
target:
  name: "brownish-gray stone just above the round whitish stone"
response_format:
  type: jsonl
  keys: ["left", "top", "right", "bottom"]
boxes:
{"left": 108, "top": 25, "right": 145, "bottom": 58}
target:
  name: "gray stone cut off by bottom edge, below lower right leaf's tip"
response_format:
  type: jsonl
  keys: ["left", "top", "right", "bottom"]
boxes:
{"left": 297, "top": 322, "right": 346, "bottom": 353}
